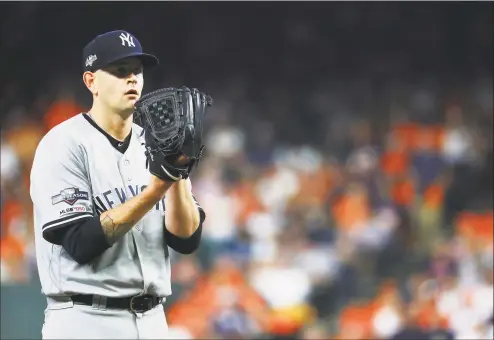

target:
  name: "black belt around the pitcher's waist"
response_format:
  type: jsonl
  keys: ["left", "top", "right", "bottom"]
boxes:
{"left": 71, "top": 294, "right": 163, "bottom": 313}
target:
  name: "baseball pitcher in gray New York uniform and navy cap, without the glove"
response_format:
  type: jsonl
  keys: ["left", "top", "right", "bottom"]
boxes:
{"left": 30, "top": 31, "right": 205, "bottom": 339}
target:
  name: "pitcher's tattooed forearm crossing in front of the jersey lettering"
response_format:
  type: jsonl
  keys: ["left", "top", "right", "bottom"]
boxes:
{"left": 100, "top": 178, "right": 171, "bottom": 244}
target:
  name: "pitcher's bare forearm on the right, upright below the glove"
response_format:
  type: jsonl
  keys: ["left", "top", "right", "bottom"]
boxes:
{"left": 165, "top": 180, "right": 200, "bottom": 238}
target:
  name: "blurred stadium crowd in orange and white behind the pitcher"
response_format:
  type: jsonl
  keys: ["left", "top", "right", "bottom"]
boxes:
{"left": 0, "top": 2, "right": 493, "bottom": 339}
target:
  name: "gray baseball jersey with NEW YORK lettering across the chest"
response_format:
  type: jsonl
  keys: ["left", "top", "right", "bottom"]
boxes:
{"left": 30, "top": 114, "right": 200, "bottom": 297}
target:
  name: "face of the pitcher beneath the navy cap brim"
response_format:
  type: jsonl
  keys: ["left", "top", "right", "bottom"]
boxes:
{"left": 95, "top": 58, "right": 144, "bottom": 112}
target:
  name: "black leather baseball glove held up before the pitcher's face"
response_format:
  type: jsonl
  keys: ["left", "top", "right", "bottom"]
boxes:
{"left": 134, "top": 87, "right": 213, "bottom": 182}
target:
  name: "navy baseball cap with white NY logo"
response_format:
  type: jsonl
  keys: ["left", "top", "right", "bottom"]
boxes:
{"left": 82, "top": 30, "right": 159, "bottom": 72}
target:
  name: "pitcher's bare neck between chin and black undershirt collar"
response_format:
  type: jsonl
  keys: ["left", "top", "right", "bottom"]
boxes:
{"left": 88, "top": 104, "right": 132, "bottom": 141}
